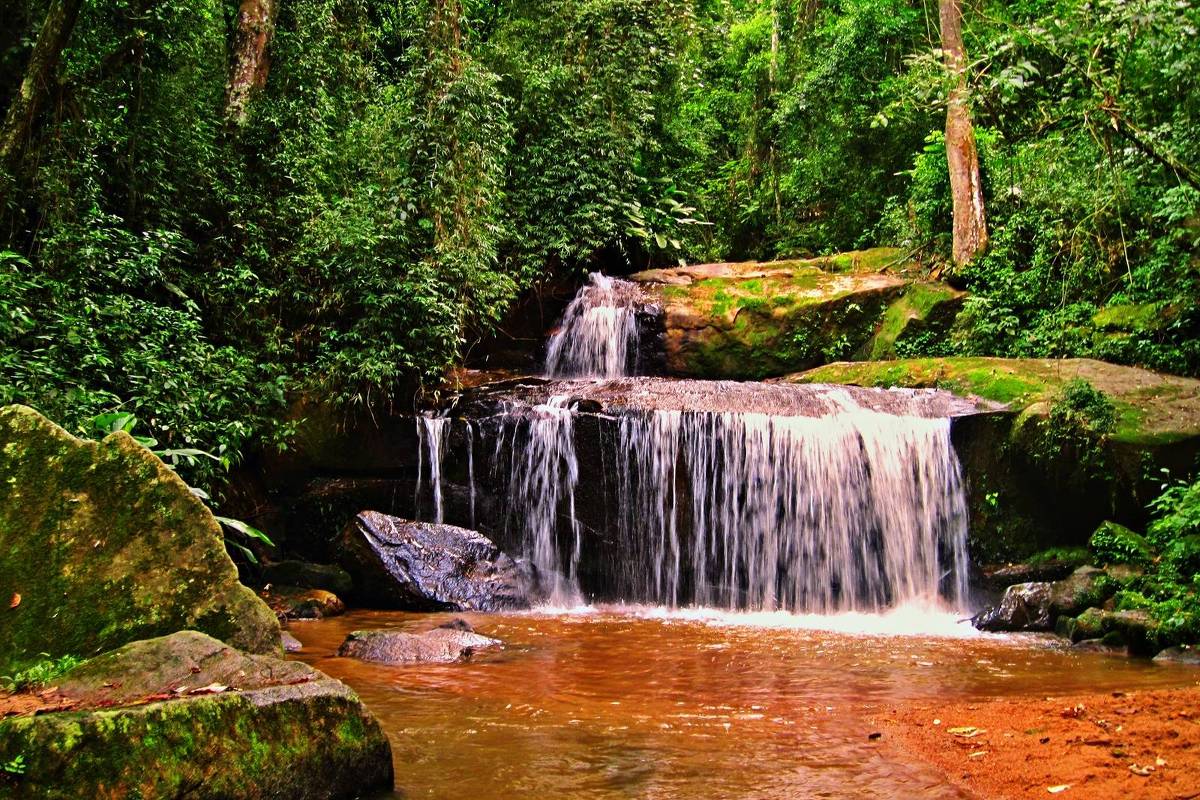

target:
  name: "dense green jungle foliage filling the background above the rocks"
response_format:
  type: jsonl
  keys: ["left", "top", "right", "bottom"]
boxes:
{"left": 0, "top": 0, "right": 1200, "bottom": 470}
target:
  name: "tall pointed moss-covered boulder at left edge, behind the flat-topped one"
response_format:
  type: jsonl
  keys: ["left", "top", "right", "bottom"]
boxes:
{"left": 0, "top": 405, "right": 280, "bottom": 674}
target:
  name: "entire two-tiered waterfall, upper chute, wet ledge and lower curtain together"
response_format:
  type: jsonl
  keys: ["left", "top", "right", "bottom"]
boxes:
{"left": 418, "top": 273, "right": 978, "bottom": 614}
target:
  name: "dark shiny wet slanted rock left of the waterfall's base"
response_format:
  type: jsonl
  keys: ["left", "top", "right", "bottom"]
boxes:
{"left": 341, "top": 511, "right": 536, "bottom": 610}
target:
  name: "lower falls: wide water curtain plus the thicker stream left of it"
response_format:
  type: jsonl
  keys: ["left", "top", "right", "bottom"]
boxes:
{"left": 497, "top": 391, "right": 967, "bottom": 613}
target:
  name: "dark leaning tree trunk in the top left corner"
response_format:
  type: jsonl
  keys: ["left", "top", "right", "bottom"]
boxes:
{"left": 0, "top": 0, "right": 83, "bottom": 167}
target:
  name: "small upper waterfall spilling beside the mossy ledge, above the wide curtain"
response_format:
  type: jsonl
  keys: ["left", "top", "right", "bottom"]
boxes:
{"left": 546, "top": 272, "right": 641, "bottom": 378}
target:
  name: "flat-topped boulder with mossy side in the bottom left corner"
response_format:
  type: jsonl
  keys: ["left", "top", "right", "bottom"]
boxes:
{"left": 0, "top": 631, "right": 392, "bottom": 800}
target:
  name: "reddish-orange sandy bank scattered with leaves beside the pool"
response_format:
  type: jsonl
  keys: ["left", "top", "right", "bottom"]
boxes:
{"left": 874, "top": 686, "right": 1200, "bottom": 800}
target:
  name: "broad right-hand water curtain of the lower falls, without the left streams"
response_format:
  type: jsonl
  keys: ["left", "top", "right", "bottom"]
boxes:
{"left": 613, "top": 410, "right": 967, "bottom": 613}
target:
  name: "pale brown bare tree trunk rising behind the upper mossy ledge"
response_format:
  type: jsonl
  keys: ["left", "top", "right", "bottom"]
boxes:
{"left": 938, "top": 0, "right": 988, "bottom": 266}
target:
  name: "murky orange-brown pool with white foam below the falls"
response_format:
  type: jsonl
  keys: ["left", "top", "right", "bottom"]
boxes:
{"left": 290, "top": 608, "right": 1196, "bottom": 800}
